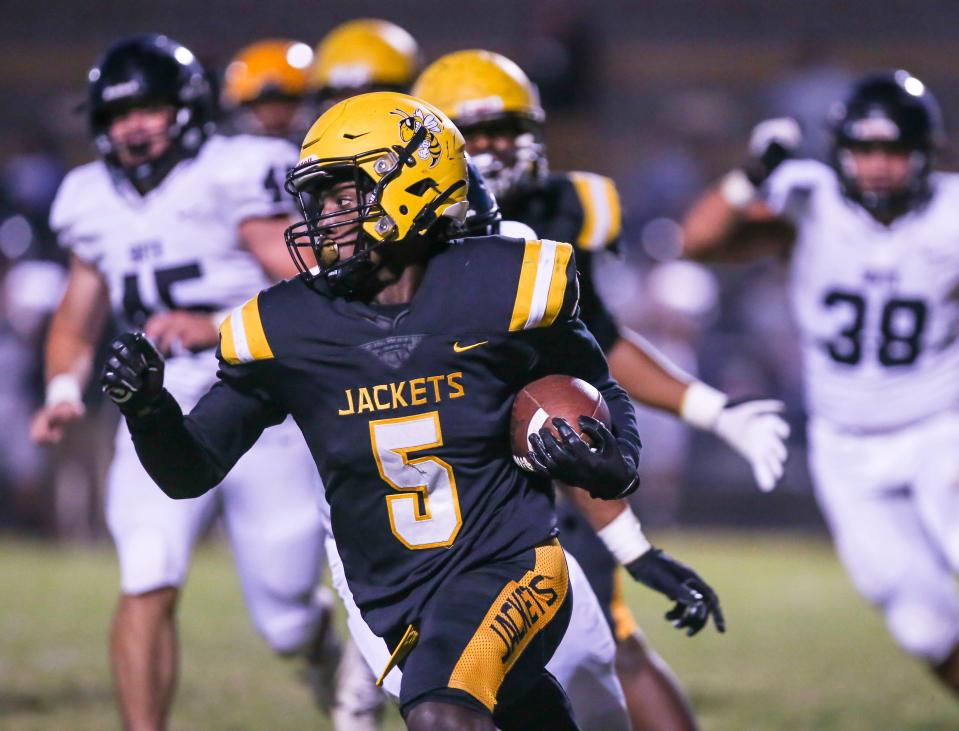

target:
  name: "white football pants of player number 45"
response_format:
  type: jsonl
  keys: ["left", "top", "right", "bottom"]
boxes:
{"left": 106, "top": 419, "right": 323, "bottom": 653}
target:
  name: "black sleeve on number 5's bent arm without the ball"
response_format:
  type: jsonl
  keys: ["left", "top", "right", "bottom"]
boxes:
{"left": 127, "top": 364, "right": 286, "bottom": 498}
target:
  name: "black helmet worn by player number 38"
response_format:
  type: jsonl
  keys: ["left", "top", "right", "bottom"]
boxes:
{"left": 829, "top": 69, "right": 945, "bottom": 216}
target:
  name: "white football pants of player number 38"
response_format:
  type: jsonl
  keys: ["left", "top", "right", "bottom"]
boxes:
{"left": 809, "top": 412, "right": 959, "bottom": 664}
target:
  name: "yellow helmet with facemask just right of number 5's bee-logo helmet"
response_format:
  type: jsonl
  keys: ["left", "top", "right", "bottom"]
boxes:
{"left": 412, "top": 49, "right": 547, "bottom": 200}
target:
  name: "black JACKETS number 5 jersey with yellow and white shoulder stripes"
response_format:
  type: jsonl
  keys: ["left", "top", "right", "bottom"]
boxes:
{"left": 197, "top": 237, "right": 639, "bottom": 635}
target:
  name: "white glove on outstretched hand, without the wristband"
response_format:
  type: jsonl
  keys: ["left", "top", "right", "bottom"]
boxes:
{"left": 713, "top": 399, "right": 789, "bottom": 492}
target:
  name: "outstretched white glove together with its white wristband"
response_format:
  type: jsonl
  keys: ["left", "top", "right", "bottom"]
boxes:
{"left": 680, "top": 381, "right": 789, "bottom": 492}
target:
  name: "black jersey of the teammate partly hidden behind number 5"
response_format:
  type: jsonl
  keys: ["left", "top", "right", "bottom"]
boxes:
{"left": 501, "top": 172, "right": 622, "bottom": 351}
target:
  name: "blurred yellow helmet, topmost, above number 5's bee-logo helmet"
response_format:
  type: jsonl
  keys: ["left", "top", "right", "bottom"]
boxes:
{"left": 310, "top": 19, "right": 419, "bottom": 97}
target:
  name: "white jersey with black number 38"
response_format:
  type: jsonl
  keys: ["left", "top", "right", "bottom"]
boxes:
{"left": 767, "top": 161, "right": 959, "bottom": 431}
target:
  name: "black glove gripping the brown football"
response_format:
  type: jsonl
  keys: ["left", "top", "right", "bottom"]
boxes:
{"left": 528, "top": 416, "right": 639, "bottom": 500}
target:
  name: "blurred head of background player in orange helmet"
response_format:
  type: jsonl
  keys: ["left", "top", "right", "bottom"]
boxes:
{"left": 222, "top": 38, "right": 313, "bottom": 144}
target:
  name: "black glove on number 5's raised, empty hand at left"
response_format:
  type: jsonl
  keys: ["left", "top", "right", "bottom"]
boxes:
{"left": 100, "top": 332, "right": 163, "bottom": 416}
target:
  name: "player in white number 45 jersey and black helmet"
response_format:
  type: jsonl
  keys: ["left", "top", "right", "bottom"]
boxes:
{"left": 32, "top": 35, "right": 323, "bottom": 730}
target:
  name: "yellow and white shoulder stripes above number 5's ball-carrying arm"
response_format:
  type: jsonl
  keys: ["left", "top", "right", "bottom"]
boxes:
{"left": 509, "top": 239, "right": 573, "bottom": 332}
